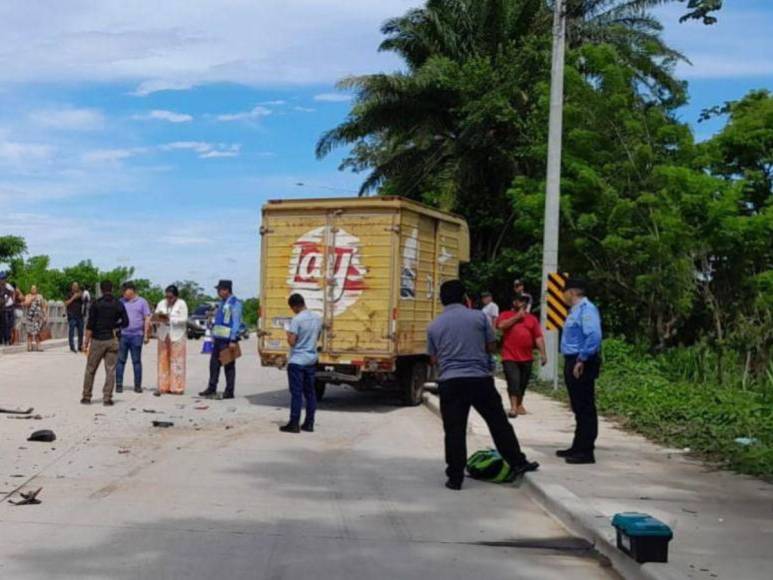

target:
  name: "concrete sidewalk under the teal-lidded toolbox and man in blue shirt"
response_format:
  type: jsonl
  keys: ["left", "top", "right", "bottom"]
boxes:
{"left": 426, "top": 380, "right": 773, "bottom": 580}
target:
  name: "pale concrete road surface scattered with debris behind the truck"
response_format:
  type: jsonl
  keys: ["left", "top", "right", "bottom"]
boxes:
{"left": 0, "top": 343, "right": 612, "bottom": 580}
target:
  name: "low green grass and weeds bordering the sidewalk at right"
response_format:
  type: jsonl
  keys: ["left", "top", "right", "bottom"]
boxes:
{"left": 536, "top": 339, "right": 773, "bottom": 480}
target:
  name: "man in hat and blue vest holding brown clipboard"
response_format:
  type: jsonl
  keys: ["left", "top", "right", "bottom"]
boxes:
{"left": 199, "top": 280, "right": 242, "bottom": 399}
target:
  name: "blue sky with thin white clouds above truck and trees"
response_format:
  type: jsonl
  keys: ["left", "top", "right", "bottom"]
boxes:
{"left": 0, "top": 0, "right": 773, "bottom": 296}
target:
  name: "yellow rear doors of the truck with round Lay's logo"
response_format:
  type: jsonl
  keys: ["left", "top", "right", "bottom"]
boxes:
{"left": 261, "top": 208, "right": 396, "bottom": 359}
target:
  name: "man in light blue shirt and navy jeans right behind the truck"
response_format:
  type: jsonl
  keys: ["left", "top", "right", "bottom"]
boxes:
{"left": 279, "top": 294, "right": 322, "bottom": 433}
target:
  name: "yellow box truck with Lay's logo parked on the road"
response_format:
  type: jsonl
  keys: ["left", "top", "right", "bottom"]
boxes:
{"left": 258, "top": 197, "right": 469, "bottom": 405}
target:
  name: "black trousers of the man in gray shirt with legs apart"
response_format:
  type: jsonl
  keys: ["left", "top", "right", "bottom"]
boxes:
{"left": 439, "top": 377, "right": 526, "bottom": 482}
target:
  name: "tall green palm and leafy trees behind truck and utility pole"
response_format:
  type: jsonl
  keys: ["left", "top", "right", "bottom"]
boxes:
{"left": 317, "top": 0, "right": 773, "bottom": 380}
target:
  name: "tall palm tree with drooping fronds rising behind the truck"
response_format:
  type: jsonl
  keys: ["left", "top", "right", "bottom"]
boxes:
{"left": 317, "top": 0, "right": 681, "bottom": 260}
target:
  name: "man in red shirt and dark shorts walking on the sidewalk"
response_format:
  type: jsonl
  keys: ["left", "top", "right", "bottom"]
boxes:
{"left": 497, "top": 294, "right": 548, "bottom": 417}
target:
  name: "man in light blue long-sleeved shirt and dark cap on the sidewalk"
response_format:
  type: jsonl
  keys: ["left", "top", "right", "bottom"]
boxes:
{"left": 556, "top": 279, "right": 602, "bottom": 464}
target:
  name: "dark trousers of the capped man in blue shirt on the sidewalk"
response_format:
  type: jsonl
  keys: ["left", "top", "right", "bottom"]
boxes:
{"left": 564, "top": 355, "right": 601, "bottom": 453}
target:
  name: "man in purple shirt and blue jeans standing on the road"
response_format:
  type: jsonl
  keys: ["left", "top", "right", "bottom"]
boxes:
{"left": 115, "top": 282, "right": 152, "bottom": 393}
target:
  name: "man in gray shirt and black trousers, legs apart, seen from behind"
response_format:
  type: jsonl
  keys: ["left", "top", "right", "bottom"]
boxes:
{"left": 427, "top": 280, "right": 539, "bottom": 490}
